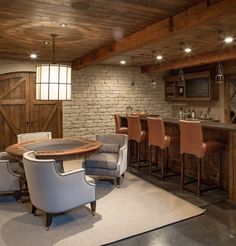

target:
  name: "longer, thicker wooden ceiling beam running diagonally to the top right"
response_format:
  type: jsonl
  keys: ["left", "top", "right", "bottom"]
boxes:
{"left": 72, "top": 0, "right": 236, "bottom": 69}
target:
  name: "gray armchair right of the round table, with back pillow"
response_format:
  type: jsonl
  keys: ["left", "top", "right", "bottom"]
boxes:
{"left": 83, "top": 134, "right": 128, "bottom": 187}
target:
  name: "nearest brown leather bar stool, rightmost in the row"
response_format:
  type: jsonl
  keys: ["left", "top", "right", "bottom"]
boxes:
{"left": 180, "top": 120, "right": 224, "bottom": 196}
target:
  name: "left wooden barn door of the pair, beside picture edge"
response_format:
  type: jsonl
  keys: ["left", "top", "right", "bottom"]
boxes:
{"left": 0, "top": 73, "right": 30, "bottom": 149}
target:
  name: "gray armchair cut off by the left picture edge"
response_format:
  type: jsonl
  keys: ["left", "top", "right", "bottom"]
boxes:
{"left": 0, "top": 152, "right": 21, "bottom": 200}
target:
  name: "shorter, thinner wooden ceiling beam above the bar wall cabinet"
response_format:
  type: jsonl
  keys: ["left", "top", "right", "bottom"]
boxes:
{"left": 141, "top": 48, "right": 236, "bottom": 73}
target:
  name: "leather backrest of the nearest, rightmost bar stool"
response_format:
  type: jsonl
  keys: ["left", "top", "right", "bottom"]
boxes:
{"left": 179, "top": 120, "right": 204, "bottom": 157}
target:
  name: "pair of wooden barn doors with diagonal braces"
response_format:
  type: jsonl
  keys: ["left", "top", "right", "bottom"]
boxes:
{"left": 0, "top": 72, "right": 62, "bottom": 150}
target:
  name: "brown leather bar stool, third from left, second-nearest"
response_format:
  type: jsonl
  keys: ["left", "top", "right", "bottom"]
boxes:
{"left": 147, "top": 117, "right": 179, "bottom": 180}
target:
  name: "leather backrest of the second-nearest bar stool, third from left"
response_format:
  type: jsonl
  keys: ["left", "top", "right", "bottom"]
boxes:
{"left": 147, "top": 117, "right": 165, "bottom": 148}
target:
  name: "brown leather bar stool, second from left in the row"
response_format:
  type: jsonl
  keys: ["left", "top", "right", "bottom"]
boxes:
{"left": 127, "top": 116, "right": 147, "bottom": 168}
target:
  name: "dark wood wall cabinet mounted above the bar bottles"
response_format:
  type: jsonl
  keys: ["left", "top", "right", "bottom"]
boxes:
{"left": 164, "top": 71, "right": 219, "bottom": 101}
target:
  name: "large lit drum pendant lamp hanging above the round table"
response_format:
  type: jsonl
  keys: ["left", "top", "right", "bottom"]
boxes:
{"left": 36, "top": 34, "right": 71, "bottom": 100}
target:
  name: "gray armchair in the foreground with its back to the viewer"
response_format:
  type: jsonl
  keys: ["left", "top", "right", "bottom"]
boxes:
{"left": 23, "top": 151, "right": 96, "bottom": 230}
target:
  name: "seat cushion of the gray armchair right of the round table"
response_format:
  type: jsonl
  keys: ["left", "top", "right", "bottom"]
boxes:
{"left": 86, "top": 153, "right": 119, "bottom": 170}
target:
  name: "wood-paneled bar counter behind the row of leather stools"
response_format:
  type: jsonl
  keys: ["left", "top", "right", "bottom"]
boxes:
{"left": 122, "top": 116, "right": 236, "bottom": 203}
